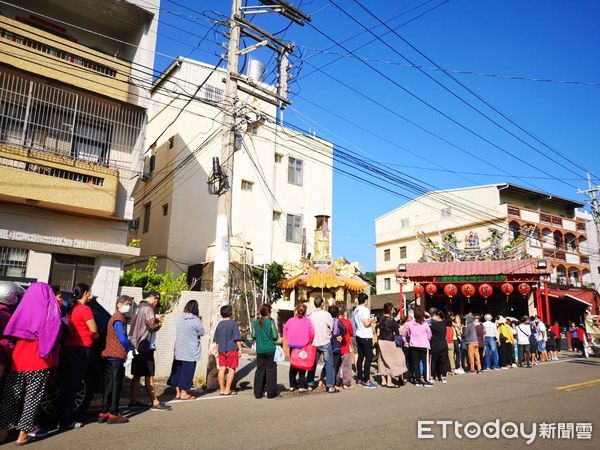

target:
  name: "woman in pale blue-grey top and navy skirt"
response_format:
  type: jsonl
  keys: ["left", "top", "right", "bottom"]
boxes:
{"left": 167, "top": 300, "right": 204, "bottom": 400}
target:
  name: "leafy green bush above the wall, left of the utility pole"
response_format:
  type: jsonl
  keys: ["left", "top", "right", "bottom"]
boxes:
{"left": 119, "top": 256, "right": 189, "bottom": 314}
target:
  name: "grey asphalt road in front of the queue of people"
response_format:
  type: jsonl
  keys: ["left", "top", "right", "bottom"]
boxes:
{"left": 7, "top": 359, "right": 600, "bottom": 449}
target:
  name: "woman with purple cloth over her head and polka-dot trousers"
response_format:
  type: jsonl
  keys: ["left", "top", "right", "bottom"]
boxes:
{"left": 0, "top": 283, "right": 61, "bottom": 445}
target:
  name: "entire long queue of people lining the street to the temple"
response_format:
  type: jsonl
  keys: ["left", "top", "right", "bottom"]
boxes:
{"left": 0, "top": 282, "right": 585, "bottom": 445}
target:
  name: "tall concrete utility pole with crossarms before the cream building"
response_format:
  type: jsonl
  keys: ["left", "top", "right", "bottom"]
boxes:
{"left": 209, "top": 0, "right": 310, "bottom": 336}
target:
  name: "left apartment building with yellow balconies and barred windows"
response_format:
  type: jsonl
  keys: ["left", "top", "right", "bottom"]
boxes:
{"left": 0, "top": 0, "right": 160, "bottom": 310}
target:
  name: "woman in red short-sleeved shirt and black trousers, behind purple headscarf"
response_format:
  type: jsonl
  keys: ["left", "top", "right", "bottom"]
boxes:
{"left": 59, "top": 283, "right": 98, "bottom": 430}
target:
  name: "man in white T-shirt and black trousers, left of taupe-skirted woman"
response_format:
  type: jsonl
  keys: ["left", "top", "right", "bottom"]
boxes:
{"left": 352, "top": 292, "right": 377, "bottom": 389}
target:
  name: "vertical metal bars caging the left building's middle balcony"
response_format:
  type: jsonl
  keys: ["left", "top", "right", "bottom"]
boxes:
{"left": 0, "top": 70, "right": 145, "bottom": 169}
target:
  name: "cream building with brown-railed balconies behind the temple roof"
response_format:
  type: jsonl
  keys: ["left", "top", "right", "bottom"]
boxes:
{"left": 375, "top": 183, "right": 600, "bottom": 294}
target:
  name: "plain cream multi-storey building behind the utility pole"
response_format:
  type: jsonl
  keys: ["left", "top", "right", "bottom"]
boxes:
{"left": 130, "top": 58, "right": 333, "bottom": 280}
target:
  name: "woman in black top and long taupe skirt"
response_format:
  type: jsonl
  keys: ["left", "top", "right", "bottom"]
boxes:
{"left": 377, "top": 303, "right": 407, "bottom": 388}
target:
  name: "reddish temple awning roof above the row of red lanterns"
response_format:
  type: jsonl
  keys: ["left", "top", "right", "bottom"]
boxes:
{"left": 396, "top": 259, "right": 552, "bottom": 282}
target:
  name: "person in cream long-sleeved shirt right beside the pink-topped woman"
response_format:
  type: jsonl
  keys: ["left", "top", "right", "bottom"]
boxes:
{"left": 307, "top": 297, "right": 337, "bottom": 393}
